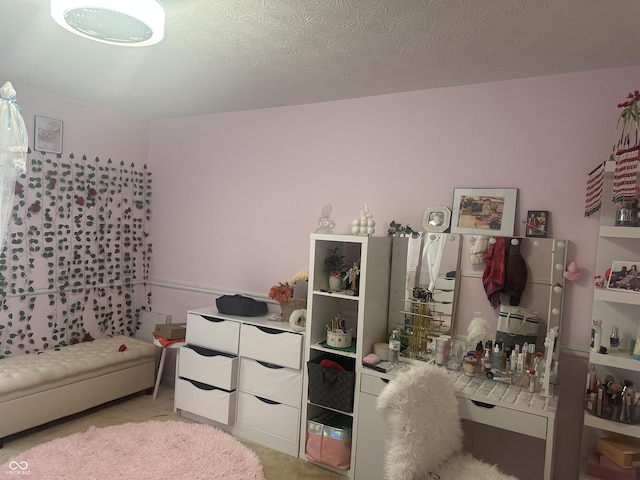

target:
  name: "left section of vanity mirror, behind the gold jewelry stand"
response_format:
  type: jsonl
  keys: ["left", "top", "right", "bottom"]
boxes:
{"left": 389, "top": 232, "right": 461, "bottom": 359}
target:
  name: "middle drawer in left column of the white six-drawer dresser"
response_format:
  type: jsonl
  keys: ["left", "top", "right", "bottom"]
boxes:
{"left": 178, "top": 345, "right": 238, "bottom": 390}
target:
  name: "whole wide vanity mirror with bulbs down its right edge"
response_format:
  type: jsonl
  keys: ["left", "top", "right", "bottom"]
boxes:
{"left": 389, "top": 232, "right": 568, "bottom": 370}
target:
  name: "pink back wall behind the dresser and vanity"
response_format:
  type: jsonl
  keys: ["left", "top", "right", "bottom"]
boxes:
{"left": 149, "top": 68, "right": 640, "bottom": 348}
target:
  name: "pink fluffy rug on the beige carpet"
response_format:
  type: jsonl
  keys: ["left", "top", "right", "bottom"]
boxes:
{"left": 0, "top": 421, "right": 264, "bottom": 480}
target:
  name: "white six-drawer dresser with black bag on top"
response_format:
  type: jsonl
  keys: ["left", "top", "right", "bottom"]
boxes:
{"left": 175, "top": 307, "right": 304, "bottom": 456}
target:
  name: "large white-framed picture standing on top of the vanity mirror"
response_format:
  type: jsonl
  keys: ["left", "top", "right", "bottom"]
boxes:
{"left": 451, "top": 188, "right": 518, "bottom": 237}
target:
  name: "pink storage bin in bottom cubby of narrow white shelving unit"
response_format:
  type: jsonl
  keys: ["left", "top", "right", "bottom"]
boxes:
{"left": 306, "top": 414, "right": 353, "bottom": 470}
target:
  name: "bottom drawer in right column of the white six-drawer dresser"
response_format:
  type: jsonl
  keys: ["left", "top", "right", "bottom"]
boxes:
{"left": 236, "top": 392, "right": 300, "bottom": 442}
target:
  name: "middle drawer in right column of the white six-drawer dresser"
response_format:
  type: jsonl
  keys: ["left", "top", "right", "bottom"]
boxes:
{"left": 238, "top": 358, "right": 302, "bottom": 407}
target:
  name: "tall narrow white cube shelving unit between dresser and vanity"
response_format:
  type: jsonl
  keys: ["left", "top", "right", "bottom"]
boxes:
{"left": 299, "top": 234, "right": 391, "bottom": 478}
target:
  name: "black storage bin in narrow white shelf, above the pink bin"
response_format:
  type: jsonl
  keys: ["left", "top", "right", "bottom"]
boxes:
{"left": 307, "top": 355, "right": 355, "bottom": 413}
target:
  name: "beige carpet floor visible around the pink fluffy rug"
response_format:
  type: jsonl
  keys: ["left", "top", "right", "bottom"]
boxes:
{"left": 0, "top": 384, "right": 345, "bottom": 480}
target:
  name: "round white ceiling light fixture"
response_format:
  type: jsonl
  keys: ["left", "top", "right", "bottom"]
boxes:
{"left": 51, "top": 0, "right": 165, "bottom": 47}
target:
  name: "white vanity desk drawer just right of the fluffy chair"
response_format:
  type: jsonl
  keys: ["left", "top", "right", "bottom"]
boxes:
{"left": 458, "top": 398, "right": 548, "bottom": 440}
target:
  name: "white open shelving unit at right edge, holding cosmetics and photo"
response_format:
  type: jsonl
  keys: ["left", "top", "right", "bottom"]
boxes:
{"left": 580, "top": 161, "right": 640, "bottom": 480}
